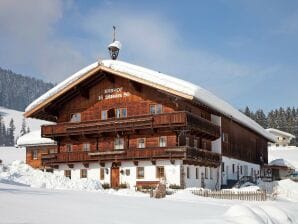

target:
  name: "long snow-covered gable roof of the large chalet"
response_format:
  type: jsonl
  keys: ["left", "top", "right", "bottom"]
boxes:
{"left": 25, "top": 60, "right": 275, "bottom": 142}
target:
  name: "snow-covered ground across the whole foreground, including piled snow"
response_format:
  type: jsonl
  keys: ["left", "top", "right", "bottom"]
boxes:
{"left": 0, "top": 147, "right": 298, "bottom": 224}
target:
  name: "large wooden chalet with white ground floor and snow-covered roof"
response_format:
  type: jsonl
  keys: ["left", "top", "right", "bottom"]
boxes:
{"left": 25, "top": 49, "right": 272, "bottom": 189}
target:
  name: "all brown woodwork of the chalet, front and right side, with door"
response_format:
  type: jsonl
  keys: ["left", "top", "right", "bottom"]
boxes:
{"left": 22, "top": 64, "right": 268, "bottom": 187}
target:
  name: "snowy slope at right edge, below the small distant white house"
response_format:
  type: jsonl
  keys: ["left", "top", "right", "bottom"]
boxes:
{"left": 268, "top": 146, "right": 298, "bottom": 170}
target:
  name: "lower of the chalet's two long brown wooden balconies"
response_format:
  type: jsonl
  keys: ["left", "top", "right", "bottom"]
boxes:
{"left": 42, "top": 147, "right": 221, "bottom": 167}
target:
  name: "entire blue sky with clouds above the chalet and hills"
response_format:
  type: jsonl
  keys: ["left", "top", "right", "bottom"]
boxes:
{"left": 0, "top": 0, "right": 298, "bottom": 111}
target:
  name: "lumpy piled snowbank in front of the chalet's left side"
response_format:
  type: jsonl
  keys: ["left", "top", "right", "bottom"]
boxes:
{"left": 0, "top": 161, "right": 102, "bottom": 191}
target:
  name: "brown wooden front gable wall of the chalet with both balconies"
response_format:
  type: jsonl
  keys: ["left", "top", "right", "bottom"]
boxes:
{"left": 35, "top": 75, "right": 220, "bottom": 167}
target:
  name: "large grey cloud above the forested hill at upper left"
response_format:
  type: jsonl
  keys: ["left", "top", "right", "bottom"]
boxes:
{"left": 0, "top": 0, "right": 85, "bottom": 81}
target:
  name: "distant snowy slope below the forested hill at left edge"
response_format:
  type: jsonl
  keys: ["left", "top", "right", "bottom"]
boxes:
{"left": 0, "top": 107, "right": 50, "bottom": 138}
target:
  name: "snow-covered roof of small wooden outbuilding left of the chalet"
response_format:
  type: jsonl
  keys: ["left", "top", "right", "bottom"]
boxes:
{"left": 17, "top": 130, "right": 56, "bottom": 146}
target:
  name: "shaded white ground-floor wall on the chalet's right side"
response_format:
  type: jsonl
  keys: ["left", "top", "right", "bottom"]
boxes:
{"left": 221, "top": 156, "right": 260, "bottom": 185}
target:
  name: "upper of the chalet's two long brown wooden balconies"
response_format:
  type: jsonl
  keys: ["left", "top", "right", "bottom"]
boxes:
{"left": 41, "top": 111, "right": 220, "bottom": 140}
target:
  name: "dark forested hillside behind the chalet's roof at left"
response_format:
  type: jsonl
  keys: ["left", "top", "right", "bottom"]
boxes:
{"left": 0, "top": 68, "right": 54, "bottom": 111}
